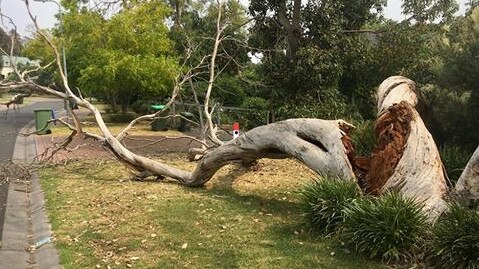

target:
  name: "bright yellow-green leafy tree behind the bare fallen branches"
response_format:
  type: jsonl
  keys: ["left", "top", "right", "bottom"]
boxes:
{"left": 64, "top": 1, "right": 177, "bottom": 114}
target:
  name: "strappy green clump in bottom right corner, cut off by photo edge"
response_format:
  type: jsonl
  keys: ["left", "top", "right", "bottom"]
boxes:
{"left": 430, "top": 204, "right": 479, "bottom": 268}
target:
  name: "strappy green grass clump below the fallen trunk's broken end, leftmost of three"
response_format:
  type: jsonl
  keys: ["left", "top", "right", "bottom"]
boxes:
{"left": 300, "top": 179, "right": 361, "bottom": 234}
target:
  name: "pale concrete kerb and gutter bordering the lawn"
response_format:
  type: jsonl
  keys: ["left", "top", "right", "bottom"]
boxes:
{"left": 0, "top": 121, "right": 61, "bottom": 269}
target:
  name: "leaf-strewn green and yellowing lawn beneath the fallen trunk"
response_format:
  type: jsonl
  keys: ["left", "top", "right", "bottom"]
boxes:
{"left": 41, "top": 156, "right": 385, "bottom": 268}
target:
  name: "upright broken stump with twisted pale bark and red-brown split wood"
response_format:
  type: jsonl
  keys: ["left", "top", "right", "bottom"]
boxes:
{"left": 370, "top": 76, "right": 448, "bottom": 222}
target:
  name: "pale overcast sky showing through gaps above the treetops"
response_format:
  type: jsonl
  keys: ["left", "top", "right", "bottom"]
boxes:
{"left": 0, "top": 0, "right": 467, "bottom": 36}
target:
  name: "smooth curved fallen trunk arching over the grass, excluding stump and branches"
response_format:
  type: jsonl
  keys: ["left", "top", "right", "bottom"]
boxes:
{"left": 101, "top": 116, "right": 355, "bottom": 187}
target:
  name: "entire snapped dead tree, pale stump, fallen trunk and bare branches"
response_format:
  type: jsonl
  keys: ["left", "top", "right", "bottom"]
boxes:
{"left": 3, "top": 0, "right": 479, "bottom": 222}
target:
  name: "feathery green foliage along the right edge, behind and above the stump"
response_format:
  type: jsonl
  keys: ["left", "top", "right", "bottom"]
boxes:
{"left": 434, "top": 8, "right": 479, "bottom": 146}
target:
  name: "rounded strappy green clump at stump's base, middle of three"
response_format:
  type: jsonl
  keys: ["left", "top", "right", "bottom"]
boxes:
{"left": 344, "top": 192, "right": 427, "bottom": 262}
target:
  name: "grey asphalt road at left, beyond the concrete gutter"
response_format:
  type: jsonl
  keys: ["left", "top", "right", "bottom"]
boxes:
{"left": 0, "top": 99, "right": 63, "bottom": 241}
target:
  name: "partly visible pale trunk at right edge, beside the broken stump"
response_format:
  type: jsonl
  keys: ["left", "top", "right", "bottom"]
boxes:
{"left": 455, "top": 147, "right": 479, "bottom": 206}
